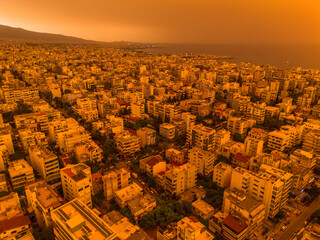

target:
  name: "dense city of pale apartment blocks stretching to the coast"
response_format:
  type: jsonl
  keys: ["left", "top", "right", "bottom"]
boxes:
{"left": 0, "top": 43, "right": 320, "bottom": 240}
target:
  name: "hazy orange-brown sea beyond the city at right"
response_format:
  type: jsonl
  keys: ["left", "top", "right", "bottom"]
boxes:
{"left": 141, "top": 44, "right": 320, "bottom": 69}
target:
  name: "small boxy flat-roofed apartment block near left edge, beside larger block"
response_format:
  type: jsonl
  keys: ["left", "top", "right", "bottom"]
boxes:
{"left": 8, "top": 159, "right": 35, "bottom": 190}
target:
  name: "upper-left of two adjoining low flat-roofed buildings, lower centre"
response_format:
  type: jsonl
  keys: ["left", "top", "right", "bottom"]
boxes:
{"left": 115, "top": 183, "right": 143, "bottom": 208}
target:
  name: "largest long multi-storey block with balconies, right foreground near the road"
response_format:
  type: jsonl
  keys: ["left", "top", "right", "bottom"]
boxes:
{"left": 230, "top": 164, "right": 293, "bottom": 218}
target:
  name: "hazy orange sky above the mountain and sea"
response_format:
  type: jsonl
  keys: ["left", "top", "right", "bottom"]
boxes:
{"left": 0, "top": 0, "right": 320, "bottom": 43}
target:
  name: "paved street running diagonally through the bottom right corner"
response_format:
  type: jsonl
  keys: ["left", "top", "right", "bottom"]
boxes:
{"left": 277, "top": 197, "right": 320, "bottom": 240}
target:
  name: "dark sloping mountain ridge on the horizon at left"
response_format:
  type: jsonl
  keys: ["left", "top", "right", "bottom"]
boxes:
{"left": 0, "top": 25, "right": 105, "bottom": 44}
